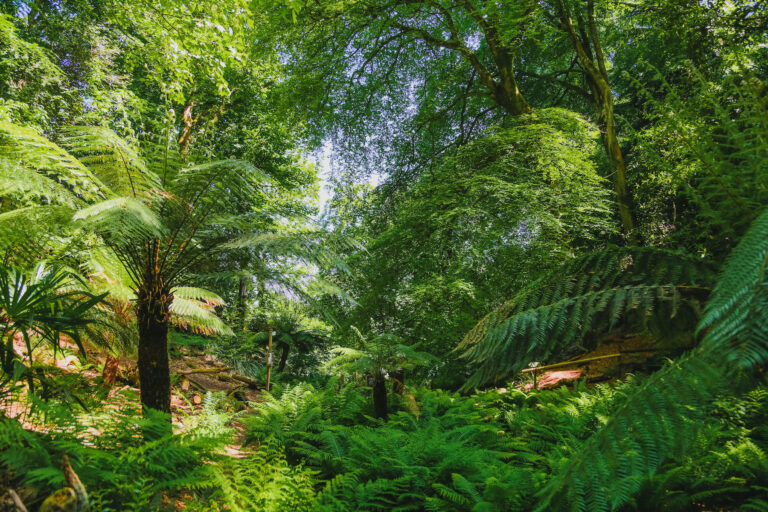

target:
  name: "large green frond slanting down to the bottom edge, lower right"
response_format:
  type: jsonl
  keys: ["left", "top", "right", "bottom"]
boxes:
{"left": 537, "top": 351, "right": 723, "bottom": 512}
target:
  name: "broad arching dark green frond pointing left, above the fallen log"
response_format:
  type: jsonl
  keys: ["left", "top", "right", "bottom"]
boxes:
{"left": 456, "top": 248, "right": 713, "bottom": 389}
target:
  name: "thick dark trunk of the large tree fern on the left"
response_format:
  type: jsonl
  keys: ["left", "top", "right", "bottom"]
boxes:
{"left": 136, "top": 276, "right": 173, "bottom": 413}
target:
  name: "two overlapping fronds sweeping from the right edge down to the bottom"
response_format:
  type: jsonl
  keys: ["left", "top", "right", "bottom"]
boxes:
{"left": 538, "top": 211, "right": 768, "bottom": 511}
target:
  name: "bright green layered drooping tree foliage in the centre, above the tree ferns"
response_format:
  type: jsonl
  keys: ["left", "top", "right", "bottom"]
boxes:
{"left": 320, "top": 109, "right": 614, "bottom": 385}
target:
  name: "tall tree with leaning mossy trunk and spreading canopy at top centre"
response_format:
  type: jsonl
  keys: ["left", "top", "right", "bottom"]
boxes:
{"left": 280, "top": 0, "right": 634, "bottom": 237}
